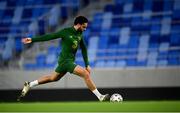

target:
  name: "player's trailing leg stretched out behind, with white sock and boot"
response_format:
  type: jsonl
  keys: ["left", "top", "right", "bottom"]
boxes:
{"left": 17, "top": 72, "right": 65, "bottom": 101}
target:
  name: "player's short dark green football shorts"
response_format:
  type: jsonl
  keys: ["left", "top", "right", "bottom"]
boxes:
{"left": 55, "top": 60, "right": 77, "bottom": 73}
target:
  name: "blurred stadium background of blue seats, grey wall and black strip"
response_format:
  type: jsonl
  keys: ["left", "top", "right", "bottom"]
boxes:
{"left": 0, "top": 0, "right": 180, "bottom": 102}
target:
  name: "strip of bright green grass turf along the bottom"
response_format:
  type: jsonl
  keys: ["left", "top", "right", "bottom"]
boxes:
{"left": 0, "top": 101, "right": 180, "bottom": 112}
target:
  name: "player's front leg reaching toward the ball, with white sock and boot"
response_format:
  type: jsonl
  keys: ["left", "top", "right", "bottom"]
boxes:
{"left": 73, "top": 66, "right": 109, "bottom": 101}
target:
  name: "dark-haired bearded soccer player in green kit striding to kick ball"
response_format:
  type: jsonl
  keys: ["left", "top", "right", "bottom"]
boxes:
{"left": 18, "top": 16, "right": 109, "bottom": 101}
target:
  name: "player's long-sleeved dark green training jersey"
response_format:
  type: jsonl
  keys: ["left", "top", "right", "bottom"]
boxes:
{"left": 32, "top": 27, "right": 89, "bottom": 67}
